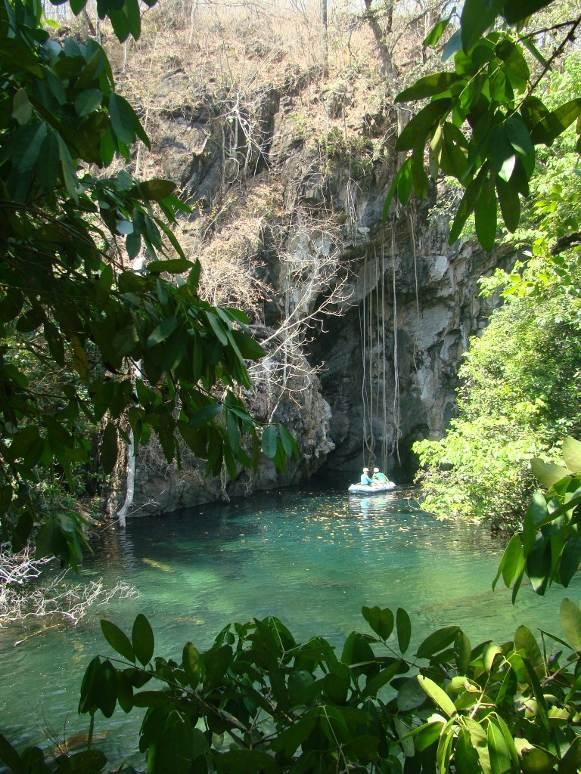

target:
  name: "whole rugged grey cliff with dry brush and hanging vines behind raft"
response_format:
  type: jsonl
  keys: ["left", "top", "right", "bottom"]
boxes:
{"left": 122, "top": 57, "right": 509, "bottom": 514}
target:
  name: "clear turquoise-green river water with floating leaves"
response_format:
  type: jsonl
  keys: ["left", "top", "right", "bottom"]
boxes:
{"left": 0, "top": 491, "right": 581, "bottom": 758}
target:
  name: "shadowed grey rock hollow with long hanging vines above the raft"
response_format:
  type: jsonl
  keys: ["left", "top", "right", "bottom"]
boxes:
{"left": 314, "top": 222, "right": 510, "bottom": 482}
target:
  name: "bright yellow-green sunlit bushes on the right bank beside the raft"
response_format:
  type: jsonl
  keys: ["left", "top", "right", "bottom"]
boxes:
{"left": 414, "top": 52, "right": 581, "bottom": 529}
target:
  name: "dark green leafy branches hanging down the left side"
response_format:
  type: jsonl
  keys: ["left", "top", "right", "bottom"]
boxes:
{"left": 0, "top": 0, "right": 295, "bottom": 564}
